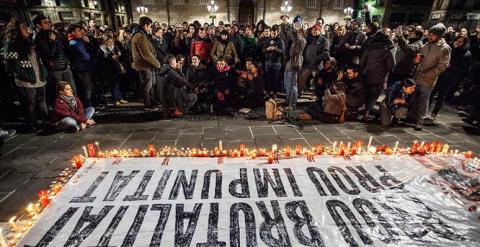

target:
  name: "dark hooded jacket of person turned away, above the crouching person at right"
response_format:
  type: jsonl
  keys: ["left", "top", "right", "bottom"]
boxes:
{"left": 360, "top": 31, "right": 395, "bottom": 85}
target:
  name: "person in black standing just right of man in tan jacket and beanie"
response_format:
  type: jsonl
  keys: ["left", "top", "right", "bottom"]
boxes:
{"left": 425, "top": 36, "right": 472, "bottom": 122}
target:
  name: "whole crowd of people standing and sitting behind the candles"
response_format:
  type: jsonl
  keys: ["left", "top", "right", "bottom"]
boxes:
{"left": 0, "top": 4, "right": 480, "bottom": 137}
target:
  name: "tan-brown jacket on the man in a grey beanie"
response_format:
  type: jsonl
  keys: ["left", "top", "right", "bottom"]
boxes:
{"left": 415, "top": 39, "right": 452, "bottom": 89}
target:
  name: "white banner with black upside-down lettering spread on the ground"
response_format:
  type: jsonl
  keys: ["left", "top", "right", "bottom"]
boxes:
{"left": 20, "top": 156, "right": 480, "bottom": 247}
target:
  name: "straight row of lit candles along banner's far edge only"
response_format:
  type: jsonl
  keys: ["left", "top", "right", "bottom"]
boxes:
{"left": 73, "top": 137, "right": 473, "bottom": 164}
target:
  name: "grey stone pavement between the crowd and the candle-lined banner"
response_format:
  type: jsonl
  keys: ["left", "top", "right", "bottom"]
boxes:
{"left": 0, "top": 109, "right": 480, "bottom": 222}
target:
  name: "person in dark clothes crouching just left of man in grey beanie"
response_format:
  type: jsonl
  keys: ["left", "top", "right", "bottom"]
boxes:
{"left": 380, "top": 79, "right": 415, "bottom": 127}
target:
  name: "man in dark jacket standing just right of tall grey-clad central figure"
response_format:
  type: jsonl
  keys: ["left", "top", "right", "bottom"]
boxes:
{"left": 298, "top": 24, "right": 330, "bottom": 93}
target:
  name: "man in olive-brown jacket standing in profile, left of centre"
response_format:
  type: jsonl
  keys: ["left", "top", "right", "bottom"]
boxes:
{"left": 132, "top": 16, "right": 160, "bottom": 111}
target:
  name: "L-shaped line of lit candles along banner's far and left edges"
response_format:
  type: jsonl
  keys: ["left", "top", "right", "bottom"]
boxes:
{"left": 0, "top": 137, "right": 478, "bottom": 246}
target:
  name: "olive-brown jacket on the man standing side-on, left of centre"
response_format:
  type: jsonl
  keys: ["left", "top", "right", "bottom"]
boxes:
{"left": 132, "top": 26, "right": 160, "bottom": 71}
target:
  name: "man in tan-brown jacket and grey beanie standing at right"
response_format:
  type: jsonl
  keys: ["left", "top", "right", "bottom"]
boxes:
{"left": 409, "top": 23, "right": 451, "bottom": 130}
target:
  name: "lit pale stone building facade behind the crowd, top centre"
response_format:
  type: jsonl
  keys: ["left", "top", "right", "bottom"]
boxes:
{"left": 131, "top": 0, "right": 354, "bottom": 25}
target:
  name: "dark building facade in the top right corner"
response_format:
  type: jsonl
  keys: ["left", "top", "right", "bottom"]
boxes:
{"left": 429, "top": 0, "right": 480, "bottom": 29}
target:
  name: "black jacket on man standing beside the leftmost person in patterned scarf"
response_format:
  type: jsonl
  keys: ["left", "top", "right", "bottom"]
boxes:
{"left": 34, "top": 30, "right": 69, "bottom": 71}
